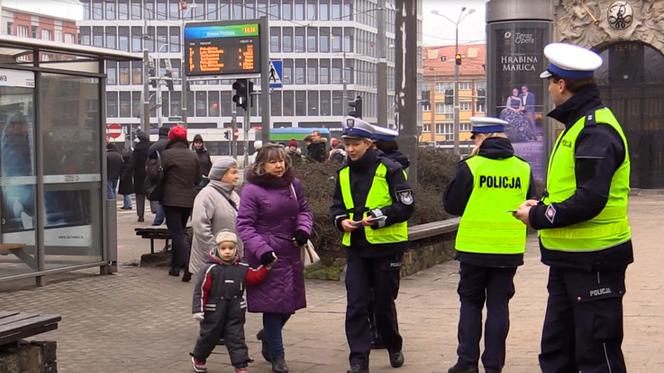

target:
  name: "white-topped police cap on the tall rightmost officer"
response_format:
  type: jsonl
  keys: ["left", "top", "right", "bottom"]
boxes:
{"left": 540, "top": 43, "right": 602, "bottom": 79}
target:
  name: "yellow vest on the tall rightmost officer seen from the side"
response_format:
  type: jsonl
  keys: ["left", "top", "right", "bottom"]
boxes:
{"left": 539, "top": 108, "right": 631, "bottom": 252}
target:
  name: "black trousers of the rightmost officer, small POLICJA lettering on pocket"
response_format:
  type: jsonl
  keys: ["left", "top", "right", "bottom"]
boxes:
{"left": 539, "top": 266, "right": 627, "bottom": 373}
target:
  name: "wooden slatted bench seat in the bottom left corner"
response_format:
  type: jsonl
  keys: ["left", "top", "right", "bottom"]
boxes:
{"left": 0, "top": 311, "right": 62, "bottom": 347}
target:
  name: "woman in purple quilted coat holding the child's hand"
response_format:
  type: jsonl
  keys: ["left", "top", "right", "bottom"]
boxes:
{"left": 237, "top": 144, "right": 313, "bottom": 373}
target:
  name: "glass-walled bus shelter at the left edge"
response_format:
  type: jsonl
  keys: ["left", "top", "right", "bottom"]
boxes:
{"left": 0, "top": 36, "right": 140, "bottom": 288}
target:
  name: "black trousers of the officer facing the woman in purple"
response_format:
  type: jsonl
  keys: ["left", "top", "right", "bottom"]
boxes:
{"left": 346, "top": 254, "right": 403, "bottom": 366}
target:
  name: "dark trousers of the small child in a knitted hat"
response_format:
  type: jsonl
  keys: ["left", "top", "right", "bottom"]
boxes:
{"left": 192, "top": 298, "right": 249, "bottom": 368}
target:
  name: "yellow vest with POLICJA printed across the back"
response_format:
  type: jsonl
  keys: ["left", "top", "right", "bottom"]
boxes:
{"left": 455, "top": 156, "right": 530, "bottom": 254}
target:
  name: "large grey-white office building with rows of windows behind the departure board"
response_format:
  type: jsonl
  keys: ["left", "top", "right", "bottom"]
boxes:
{"left": 78, "top": 0, "right": 416, "bottom": 154}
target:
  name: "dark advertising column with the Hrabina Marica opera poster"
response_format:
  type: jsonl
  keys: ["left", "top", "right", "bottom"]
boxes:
{"left": 487, "top": 0, "right": 553, "bottom": 181}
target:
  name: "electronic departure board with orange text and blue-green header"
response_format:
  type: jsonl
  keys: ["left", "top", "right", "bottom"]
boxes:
{"left": 184, "top": 21, "right": 261, "bottom": 76}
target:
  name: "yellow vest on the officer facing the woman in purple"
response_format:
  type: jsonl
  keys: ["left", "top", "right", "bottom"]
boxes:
{"left": 339, "top": 162, "right": 408, "bottom": 246}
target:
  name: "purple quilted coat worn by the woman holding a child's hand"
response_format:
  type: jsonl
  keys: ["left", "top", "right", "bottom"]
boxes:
{"left": 237, "top": 170, "right": 313, "bottom": 314}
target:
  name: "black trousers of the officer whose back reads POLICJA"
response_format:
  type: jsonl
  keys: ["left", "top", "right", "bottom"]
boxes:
{"left": 457, "top": 263, "right": 516, "bottom": 371}
